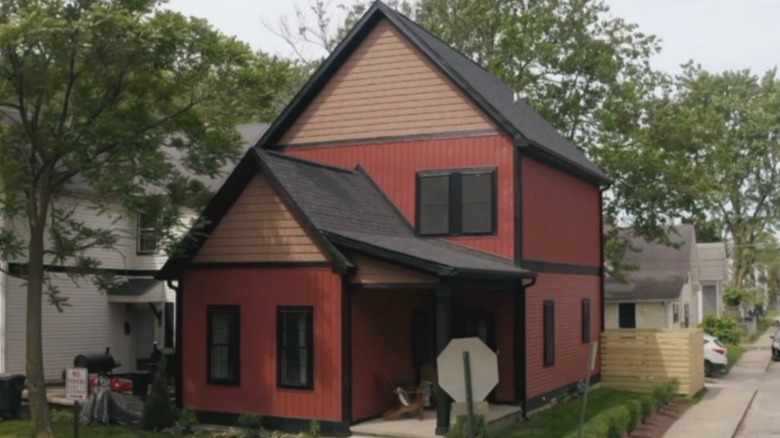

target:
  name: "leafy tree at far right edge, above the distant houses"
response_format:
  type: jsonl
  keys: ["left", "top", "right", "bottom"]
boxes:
{"left": 645, "top": 64, "right": 780, "bottom": 287}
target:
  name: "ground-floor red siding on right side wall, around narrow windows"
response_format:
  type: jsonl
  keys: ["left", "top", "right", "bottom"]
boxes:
{"left": 526, "top": 274, "right": 602, "bottom": 398}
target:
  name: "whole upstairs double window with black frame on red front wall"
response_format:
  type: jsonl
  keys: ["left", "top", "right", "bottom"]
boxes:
{"left": 417, "top": 168, "right": 496, "bottom": 236}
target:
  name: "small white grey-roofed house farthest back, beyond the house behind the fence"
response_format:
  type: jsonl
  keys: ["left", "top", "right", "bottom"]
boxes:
{"left": 696, "top": 242, "right": 729, "bottom": 316}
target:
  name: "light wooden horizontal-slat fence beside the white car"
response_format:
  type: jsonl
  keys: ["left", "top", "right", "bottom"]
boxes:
{"left": 601, "top": 329, "right": 704, "bottom": 396}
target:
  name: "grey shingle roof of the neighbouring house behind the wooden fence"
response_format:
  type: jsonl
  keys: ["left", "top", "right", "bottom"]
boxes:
{"left": 604, "top": 225, "right": 695, "bottom": 301}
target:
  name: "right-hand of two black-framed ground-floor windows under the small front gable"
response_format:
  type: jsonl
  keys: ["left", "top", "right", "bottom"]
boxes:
{"left": 277, "top": 306, "right": 314, "bottom": 389}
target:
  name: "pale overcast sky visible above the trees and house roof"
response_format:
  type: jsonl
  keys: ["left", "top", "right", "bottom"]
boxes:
{"left": 168, "top": 0, "right": 780, "bottom": 73}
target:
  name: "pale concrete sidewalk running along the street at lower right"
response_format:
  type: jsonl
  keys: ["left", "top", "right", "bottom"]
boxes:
{"left": 664, "top": 318, "right": 774, "bottom": 438}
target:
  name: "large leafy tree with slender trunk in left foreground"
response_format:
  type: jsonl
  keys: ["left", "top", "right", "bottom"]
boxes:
{"left": 0, "top": 0, "right": 295, "bottom": 437}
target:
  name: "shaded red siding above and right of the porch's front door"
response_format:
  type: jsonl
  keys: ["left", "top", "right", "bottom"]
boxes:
{"left": 453, "top": 290, "right": 515, "bottom": 402}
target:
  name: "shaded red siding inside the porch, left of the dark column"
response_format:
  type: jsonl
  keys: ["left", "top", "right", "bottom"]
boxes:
{"left": 352, "top": 290, "right": 433, "bottom": 420}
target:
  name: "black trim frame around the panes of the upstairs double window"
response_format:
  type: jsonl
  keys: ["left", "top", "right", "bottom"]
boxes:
{"left": 414, "top": 166, "right": 498, "bottom": 237}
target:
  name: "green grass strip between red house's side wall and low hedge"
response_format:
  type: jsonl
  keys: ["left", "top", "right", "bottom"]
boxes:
{"left": 496, "top": 388, "right": 637, "bottom": 438}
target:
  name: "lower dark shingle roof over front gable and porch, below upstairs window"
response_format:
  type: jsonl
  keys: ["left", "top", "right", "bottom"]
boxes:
{"left": 257, "top": 150, "right": 533, "bottom": 277}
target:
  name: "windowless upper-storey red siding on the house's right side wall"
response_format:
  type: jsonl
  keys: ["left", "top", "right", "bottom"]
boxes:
{"left": 521, "top": 156, "right": 601, "bottom": 266}
